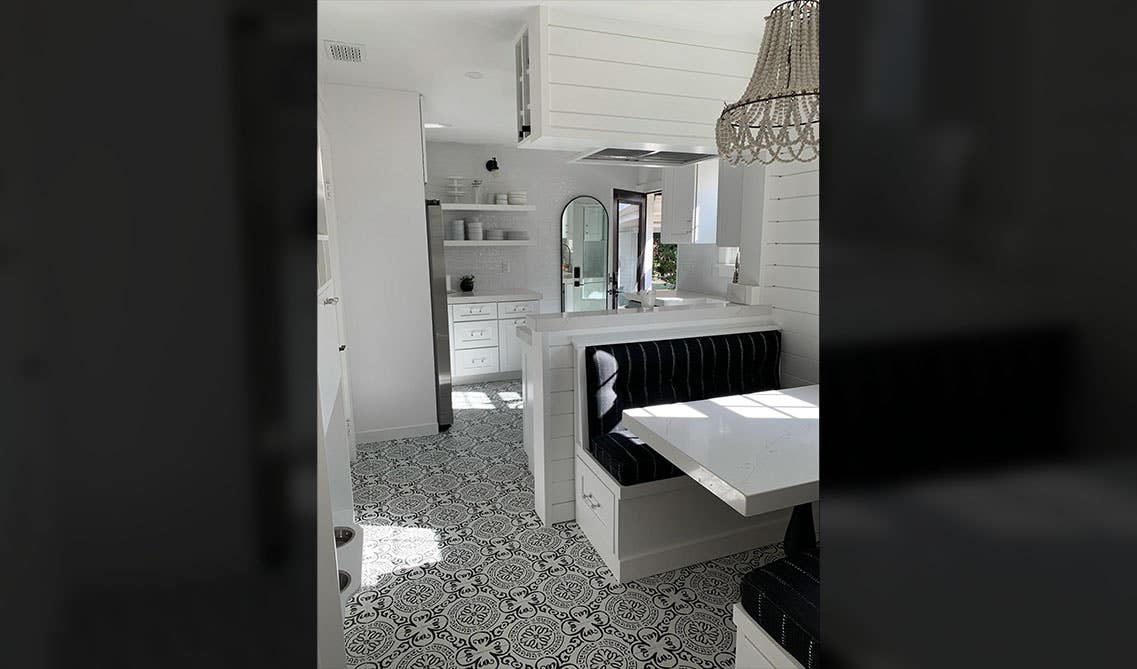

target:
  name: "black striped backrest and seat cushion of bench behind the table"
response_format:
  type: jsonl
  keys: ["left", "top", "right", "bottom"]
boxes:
{"left": 584, "top": 330, "right": 781, "bottom": 486}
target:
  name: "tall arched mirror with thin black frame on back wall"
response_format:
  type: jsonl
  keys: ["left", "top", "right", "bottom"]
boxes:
{"left": 561, "top": 196, "right": 608, "bottom": 312}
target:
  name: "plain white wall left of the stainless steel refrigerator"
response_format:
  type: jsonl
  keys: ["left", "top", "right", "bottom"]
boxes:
{"left": 321, "top": 84, "right": 438, "bottom": 443}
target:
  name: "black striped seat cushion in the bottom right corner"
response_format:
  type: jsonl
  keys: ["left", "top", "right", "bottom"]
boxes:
{"left": 741, "top": 544, "right": 821, "bottom": 669}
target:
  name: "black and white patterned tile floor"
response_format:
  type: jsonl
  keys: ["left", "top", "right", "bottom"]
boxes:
{"left": 345, "top": 381, "right": 781, "bottom": 669}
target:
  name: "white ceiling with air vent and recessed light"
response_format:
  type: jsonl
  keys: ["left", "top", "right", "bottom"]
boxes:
{"left": 316, "top": 0, "right": 778, "bottom": 144}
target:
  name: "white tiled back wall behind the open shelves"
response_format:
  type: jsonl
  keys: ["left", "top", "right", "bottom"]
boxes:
{"left": 426, "top": 142, "right": 641, "bottom": 312}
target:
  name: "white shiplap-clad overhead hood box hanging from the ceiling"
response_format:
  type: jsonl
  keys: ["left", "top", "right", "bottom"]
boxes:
{"left": 514, "top": 6, "right": 758, "bottom": 154}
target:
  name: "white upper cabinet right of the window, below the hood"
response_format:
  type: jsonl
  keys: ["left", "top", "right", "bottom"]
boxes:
{"left": 659, "top": 160, "right": 719, "bottom": 243}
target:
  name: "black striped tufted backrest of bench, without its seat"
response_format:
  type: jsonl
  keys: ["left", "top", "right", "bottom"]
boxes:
{"left": 584, "top": 330, "right": 781, "bottom": 436}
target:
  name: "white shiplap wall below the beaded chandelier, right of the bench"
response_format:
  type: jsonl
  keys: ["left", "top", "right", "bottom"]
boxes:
{"left": 758, "top": 162, "right": 821, "bottom": 388}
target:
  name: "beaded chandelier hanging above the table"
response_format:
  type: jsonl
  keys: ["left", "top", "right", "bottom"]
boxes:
{"left": 715, "top": 0, "right": 821, "bottom": 165}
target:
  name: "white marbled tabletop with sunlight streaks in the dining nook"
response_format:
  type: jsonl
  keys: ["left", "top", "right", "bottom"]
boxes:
{"left": 622, "top": 386, "right": 821, "bottom": 515}
